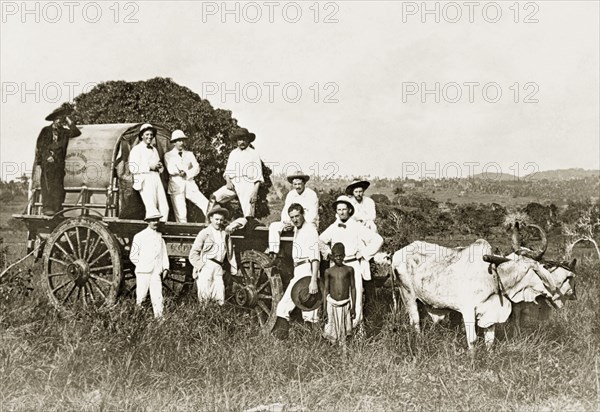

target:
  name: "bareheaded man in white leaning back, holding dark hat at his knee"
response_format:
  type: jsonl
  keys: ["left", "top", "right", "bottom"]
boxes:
{"left": 273, "top": 203, "right": 321, "bottom": 337}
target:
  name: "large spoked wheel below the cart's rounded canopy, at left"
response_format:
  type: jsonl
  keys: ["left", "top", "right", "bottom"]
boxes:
{"left": 42, "top": 217, "right": 123, "bottom": 311}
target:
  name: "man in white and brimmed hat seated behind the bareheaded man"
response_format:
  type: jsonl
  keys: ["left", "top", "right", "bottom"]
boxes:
{"left": 269, "top": 172, "right": 319, "bottom": 260}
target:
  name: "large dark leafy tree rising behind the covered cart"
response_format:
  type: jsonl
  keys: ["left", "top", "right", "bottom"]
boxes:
{"left": 68, "top": 77, "right": 271, "bottom": 221}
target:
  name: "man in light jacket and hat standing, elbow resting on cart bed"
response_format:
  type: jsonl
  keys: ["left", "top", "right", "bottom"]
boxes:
{"left": 189, "top": 206, "right": 237, "bottom": 305}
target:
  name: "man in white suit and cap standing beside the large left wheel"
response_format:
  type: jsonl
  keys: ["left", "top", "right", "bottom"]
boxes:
{"left": 129, "top": 212, "right": 169, "bottom": 318}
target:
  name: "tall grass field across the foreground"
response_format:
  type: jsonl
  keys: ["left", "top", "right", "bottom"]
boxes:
{"left": 0, "top": 199, "right": 600, "bottom": 411}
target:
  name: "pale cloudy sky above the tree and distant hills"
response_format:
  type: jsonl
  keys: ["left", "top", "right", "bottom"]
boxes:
{"left": 0, "top": 0, "right": 600, "bottom": 180}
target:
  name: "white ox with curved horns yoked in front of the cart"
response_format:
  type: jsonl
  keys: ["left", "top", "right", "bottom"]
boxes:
{"left": 392, "top": 223, "right": 576, "bottom": 349}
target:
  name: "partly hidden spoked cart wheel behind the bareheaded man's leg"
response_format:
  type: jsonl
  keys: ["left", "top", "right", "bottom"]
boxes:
{"left": 232, "top": 250, "right": 283, "bottom": 332}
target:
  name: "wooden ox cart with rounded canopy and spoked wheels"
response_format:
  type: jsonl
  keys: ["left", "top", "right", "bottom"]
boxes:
{"left": 14, "top": 124, "right": 293, "bottom": 329}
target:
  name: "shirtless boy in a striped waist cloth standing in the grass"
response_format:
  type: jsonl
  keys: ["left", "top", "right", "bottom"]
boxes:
{"left": 323, "top": 243, "right": 356, "bottom": 344}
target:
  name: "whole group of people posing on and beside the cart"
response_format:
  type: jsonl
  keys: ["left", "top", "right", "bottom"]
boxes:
{"left": 37, "top": 109, "right": 383, "bottom": 340}
